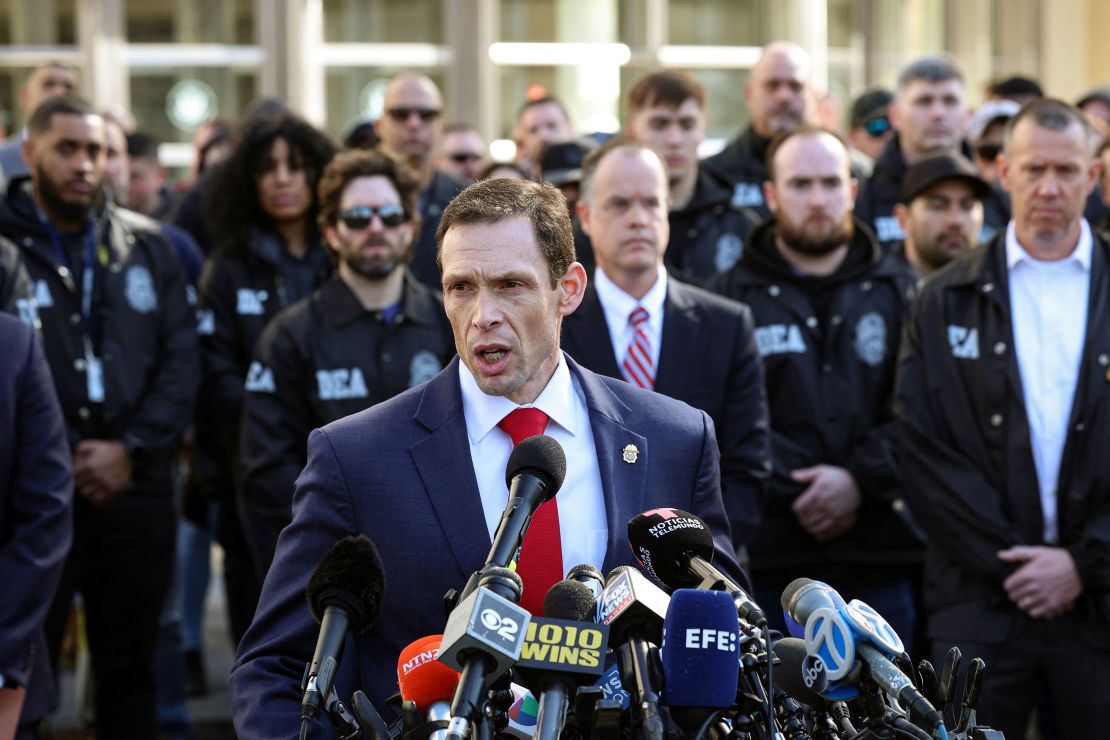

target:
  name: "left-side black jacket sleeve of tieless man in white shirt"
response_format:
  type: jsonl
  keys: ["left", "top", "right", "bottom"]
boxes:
{"left": 894, "top": 292, "right": 1019, "bottom": 586}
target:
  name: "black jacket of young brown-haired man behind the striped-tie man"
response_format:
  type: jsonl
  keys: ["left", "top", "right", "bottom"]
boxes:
{"left": 666, "top": 166, "right": 761, "bottom": 285}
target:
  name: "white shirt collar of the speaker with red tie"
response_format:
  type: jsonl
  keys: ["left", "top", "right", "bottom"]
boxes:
{"left": 458, "top": 352, "right": 578, "bottom": 445}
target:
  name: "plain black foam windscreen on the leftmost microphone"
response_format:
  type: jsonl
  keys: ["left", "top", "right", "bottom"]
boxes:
{"left": 305, "top": 535, "right": 385, "bottom": 632}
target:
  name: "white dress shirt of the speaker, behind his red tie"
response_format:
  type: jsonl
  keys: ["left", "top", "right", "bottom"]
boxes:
{"left": 458, "top": 353, "right": 608, "bottom": 577}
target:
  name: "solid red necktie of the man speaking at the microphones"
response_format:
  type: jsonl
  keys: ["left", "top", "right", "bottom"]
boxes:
{"left": 497, "top": 408, "right": 563, "bottom": 616}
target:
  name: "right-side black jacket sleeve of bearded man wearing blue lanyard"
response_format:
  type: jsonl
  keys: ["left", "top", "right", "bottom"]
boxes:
{"left": 123, "top": 235, "right": 200, "bottom": 455}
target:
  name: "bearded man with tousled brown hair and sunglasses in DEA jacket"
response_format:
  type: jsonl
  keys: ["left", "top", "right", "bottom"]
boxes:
{"left": 240, "top": 150, "right": 454, "bottom": 564}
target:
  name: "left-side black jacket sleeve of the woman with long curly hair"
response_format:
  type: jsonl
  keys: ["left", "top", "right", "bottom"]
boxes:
{"left": 201, "top": 257, "right": 246, "bottom": 428}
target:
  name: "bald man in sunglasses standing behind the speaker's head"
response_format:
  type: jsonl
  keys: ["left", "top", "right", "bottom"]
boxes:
{"left": 374, "top": 73, "right": 465, "bottom": 288}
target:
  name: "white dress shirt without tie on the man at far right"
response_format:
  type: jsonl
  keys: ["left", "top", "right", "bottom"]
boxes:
{"left": 1006, "top": 220, "right": 1092, "bottom": 544}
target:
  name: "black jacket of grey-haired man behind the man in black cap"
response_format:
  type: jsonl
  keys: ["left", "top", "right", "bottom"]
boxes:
{"left": 856, "top": 132, "right": 1010, "bottom": 255}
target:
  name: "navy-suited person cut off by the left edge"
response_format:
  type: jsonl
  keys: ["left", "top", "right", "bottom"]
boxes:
{"left": 0, "top": 314, "right": 73, "bottom": 738}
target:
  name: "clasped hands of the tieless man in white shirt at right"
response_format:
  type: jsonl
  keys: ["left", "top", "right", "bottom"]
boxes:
{"left": 998, "top": 545, "right": 1083, "bottom": 619}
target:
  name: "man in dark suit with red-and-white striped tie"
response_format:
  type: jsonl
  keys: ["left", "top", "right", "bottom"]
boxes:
{"left": 563, "top": 139, "right": 770, "bottom": 549}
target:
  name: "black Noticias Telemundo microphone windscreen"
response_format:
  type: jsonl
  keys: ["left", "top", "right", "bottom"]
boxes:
{"left": 628, "top": 509, "right": 713, "bottom": 588}
